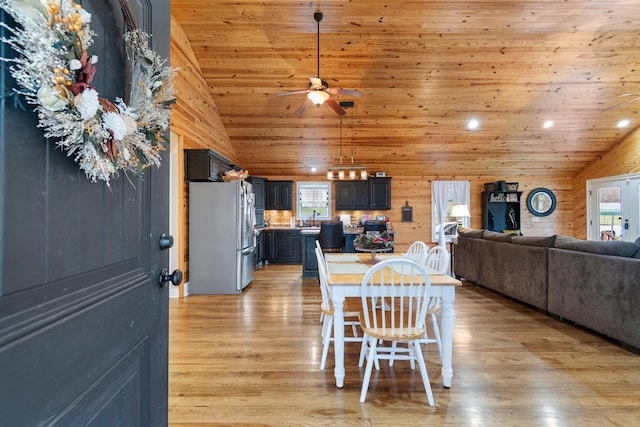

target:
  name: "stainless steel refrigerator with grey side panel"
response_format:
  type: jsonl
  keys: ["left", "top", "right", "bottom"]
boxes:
{"left": 189, "top": 181, "right": 255, "bottom": 294}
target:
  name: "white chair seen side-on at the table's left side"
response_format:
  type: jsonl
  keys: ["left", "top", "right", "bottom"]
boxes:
{"left": 316, "top": 248, "right": 363, "bottom": 370}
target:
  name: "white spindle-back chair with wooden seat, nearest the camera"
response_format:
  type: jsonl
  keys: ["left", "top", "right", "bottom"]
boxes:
{"left": 360, "top": 259, "right": 435, "bottom": 406}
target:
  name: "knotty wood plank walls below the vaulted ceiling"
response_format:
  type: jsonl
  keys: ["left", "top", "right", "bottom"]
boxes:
{"left": 171, "top": 18, "right": 640, "bottom": 290}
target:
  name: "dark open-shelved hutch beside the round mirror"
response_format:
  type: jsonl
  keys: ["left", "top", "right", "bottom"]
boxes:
{"left": 482, "top": 191, "right": 522, "bottom": 233}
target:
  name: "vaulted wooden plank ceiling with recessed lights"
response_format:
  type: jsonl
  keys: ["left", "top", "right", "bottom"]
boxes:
{"left": 171, "top": 0, "right": 640, "bottom": 178}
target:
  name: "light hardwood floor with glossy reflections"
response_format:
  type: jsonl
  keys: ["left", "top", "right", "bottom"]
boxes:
{"left": 169, "top": 265, "right": 640, "bottom": 427}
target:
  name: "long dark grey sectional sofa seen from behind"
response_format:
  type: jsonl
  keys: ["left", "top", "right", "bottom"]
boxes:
{"left": 455, "top": 229, "right": 640, "bottom": 354}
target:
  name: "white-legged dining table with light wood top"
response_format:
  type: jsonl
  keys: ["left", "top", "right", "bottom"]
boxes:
{"left": 325, "top": 253, "right": 462, "bottom": 388}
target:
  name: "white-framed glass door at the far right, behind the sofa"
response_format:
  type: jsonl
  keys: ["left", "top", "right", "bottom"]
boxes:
{"left": 587, "top": 175, "right": 640, "bottom": 242}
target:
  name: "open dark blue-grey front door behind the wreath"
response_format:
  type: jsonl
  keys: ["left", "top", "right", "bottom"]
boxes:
{"left": 0, "top": 0, "right": 169, "bottom": 426}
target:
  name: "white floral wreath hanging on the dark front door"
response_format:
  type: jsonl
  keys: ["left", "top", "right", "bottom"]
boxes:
{"left": 0, "top": 0, "right": 175, "bottom": 186}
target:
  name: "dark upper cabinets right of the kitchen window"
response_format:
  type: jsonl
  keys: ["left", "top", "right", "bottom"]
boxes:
{"left": 334, "top": 177, "right": 391, "bottom": 211}
